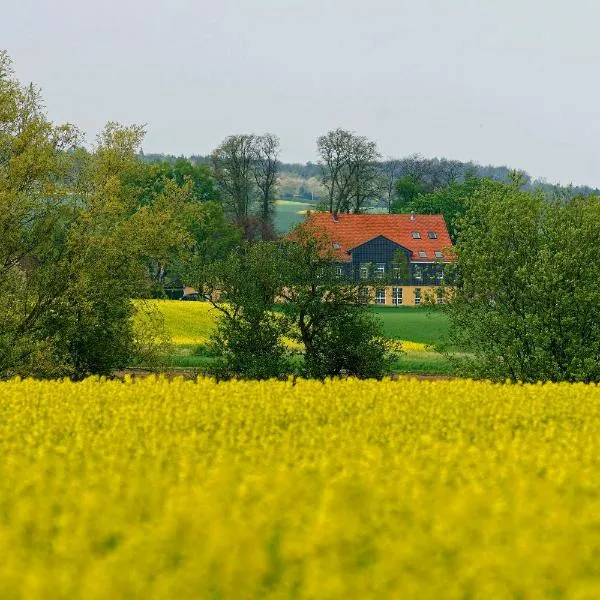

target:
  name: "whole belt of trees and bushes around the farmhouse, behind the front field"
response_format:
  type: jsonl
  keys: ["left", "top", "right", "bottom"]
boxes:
{"left": 0, "top": 52, "right": 600, "bottom": 381}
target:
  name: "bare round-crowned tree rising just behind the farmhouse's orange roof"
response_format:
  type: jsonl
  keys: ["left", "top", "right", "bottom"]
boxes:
{"left": 317, "top": 129, "right": 379, "bottom": 216}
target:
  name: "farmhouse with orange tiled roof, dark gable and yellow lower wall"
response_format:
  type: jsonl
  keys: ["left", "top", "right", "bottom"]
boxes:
{"left": 304, "top": 212, "right": 452, "bottom": 306}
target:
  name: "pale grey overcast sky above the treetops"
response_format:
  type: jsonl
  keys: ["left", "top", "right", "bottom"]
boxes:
{"left": 0, "top": 0, "right": 600, "bottom": 186}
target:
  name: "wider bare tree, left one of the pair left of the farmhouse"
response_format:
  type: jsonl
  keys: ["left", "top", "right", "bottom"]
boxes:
{"left": 211, "top": 134, "right": 256, "bottom": 239}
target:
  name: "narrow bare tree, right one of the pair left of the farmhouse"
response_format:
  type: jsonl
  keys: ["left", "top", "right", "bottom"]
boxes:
{"left": 254, "top": 133, "right": 279, "bottom": 240}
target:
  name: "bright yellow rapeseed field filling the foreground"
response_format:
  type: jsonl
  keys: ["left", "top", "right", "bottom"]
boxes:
{"left": 0, "top": 378, "right": 600, "bottom": 600}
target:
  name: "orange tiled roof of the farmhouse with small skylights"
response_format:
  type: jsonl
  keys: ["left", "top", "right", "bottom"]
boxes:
{"left": 305, "top": 212, "right": 452, "bottom": 262}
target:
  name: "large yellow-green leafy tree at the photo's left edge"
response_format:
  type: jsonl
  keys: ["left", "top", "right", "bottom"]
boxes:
{"left": 0, "top": 53, "right": 166, "bottom": 379}
